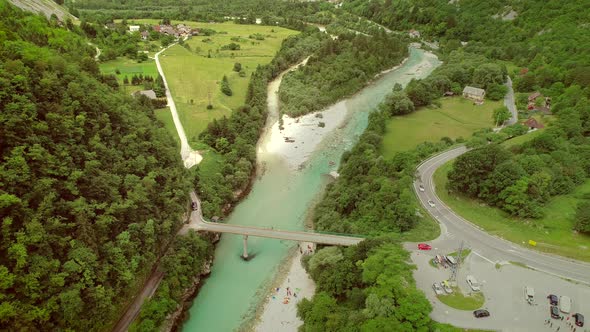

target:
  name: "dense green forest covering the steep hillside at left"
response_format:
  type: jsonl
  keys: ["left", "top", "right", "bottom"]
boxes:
{"left": 0, "top": 0, "right": 206, "bottom": 331}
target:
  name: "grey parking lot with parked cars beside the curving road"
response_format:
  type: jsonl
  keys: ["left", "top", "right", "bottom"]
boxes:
{"left": 412, "top": 248, "right": 590, "bottom": 332}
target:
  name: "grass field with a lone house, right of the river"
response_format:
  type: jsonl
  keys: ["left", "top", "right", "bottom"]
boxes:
{"left": 382, "top": 97, "right": 502, "bottom": 158}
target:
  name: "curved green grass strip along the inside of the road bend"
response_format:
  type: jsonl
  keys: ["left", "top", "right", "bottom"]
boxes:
{"left": 434, "top": 162, "right": 590, "bottom": 261}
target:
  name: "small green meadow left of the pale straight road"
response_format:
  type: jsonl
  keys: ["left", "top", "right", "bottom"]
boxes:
{"left": 99, "top": 57, "right": 158, "bottom": 93}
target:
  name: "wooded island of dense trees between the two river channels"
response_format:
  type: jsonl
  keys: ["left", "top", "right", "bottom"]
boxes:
{"left": 279, "top": 30, "right": 408, "bottom": 116}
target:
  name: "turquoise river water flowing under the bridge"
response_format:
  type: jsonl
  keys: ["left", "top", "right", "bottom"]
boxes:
{"left": 182, "top": 49, "right": 440, "bottom": 332}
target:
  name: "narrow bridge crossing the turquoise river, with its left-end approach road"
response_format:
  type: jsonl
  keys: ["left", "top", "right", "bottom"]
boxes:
{"left": 181, "top": 192, "right": 364, "bottom": 246}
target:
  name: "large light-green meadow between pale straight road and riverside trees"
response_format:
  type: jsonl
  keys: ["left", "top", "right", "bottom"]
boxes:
{"left": 128, "top": 19, "right": 298, "bottom": 146}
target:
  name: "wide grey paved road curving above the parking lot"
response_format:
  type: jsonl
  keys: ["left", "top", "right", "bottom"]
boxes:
{"left": 414, "top": 147, "right": 590, "bottom": 284}
